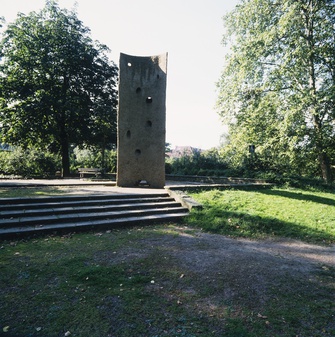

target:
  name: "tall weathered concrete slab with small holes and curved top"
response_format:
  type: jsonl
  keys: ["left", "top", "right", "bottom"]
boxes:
{"left": 117, "top": 53, "right": 167, "bottom": 188}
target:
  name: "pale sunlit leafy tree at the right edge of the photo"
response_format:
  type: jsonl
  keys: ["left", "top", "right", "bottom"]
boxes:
{"left": 218, "top": 0, "right": 335, "bottom": 183}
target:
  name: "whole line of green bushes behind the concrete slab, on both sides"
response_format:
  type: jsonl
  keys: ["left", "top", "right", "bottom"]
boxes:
{"left": 0, "top": 145, "right": 334, "bottom": 186}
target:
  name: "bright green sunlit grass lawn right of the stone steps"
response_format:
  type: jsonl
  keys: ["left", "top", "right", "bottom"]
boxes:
{"left": 187, "top": 188, "right": 335, "bottom": 244}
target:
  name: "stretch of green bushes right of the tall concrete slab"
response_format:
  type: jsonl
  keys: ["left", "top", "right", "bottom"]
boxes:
{"left": 166, "top": 144, "right": 332, "bottom": 182}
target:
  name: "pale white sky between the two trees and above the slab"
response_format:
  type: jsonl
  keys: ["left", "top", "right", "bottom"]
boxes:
{"left": 0, "top": 0, "right": 238, "bottom": 149}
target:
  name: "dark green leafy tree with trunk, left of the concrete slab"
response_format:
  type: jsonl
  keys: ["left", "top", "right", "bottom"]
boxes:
{"left": 0, "top": 1, "right": 117, "bottom": 176}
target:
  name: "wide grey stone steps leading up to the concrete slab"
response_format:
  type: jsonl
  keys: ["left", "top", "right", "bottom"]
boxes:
{"left": 0, "top": 192, "right": 188, "bottom": 238}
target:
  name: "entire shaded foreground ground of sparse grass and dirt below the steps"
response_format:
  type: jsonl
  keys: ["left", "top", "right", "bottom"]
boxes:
{"left": 0, "top": 225, "right": 335, "bottom": 337}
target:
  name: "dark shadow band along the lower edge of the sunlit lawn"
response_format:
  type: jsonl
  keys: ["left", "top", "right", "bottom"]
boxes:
{"left": 186, "top": 207, "right": 335, "bottom": 244}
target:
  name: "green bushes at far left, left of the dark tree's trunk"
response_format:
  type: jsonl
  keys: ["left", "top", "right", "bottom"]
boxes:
{"left": 0, "top": 148, "right": 61, "bottom": 177}
